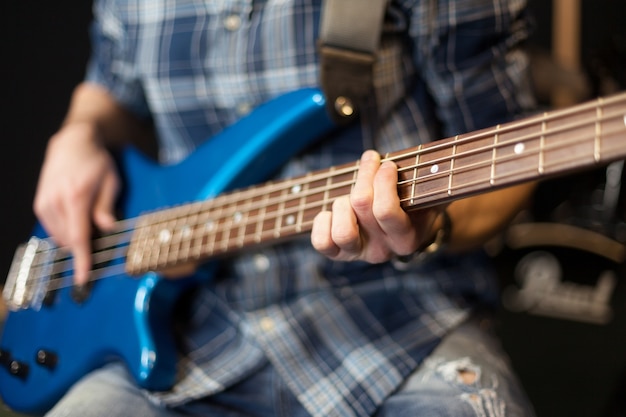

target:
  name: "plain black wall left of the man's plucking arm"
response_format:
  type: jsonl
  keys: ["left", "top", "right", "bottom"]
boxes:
{"left": 0, "top": 0, "right": 91, "bottom": 282}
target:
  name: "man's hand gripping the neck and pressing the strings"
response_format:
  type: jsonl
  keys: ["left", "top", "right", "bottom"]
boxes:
{"left": 311, "top": 151, "right": 440, "bottom": 263}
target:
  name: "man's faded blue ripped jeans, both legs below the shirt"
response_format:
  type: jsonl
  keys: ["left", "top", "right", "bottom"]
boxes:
{"left": 47, "top": 320, "right": 534, "bottom": 417}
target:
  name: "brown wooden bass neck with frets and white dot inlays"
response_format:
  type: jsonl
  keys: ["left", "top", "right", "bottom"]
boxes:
{"left": 126, "top": 94, "right": 626, "bottom": 274}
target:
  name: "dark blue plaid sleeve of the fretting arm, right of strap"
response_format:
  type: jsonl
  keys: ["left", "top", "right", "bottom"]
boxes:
{"left": 410, "top": 0, "right": 534, "bottom": 136}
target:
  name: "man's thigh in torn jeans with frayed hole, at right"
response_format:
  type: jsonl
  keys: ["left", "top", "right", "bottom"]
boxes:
{"left": 377, "top": 320, "right": 534, "bottom": 417}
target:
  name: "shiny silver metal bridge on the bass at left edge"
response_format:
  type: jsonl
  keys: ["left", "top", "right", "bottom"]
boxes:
{"left": 2, "top": 237, "right": 54, "bottom": 311}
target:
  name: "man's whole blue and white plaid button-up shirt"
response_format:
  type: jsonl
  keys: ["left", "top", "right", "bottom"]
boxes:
{"left": 87, "top": 0, "right": 531, "bottom": 417}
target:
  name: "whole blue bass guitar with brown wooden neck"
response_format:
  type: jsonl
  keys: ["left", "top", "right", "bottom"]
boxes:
{"left": 0, "top": 89, "right": 626, "bottom": 413}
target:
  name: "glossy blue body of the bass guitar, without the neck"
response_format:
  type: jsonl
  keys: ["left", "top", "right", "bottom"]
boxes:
{"left": 0, "top": 89, "right": 333, "bottom": 413}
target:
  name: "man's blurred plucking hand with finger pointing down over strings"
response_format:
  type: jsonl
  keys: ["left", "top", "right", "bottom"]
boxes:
{"left": 34, "top": 123, "right": 120, "bottom": 285}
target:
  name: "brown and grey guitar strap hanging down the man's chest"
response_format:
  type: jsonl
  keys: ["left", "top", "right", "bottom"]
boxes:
{"left": 318, "top": 0, "right": 388, "bottom": 124}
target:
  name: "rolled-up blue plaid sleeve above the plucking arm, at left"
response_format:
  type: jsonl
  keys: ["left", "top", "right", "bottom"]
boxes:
{"left": 85, "top": 0, "right": 150, "bottom": 118}
